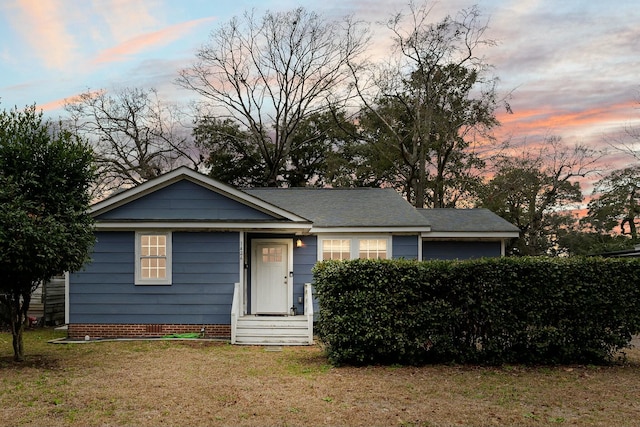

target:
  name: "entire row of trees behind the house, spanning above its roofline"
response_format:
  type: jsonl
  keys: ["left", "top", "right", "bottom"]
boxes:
{"left": 57, "top": 3, "right": 640, "bottom": 255}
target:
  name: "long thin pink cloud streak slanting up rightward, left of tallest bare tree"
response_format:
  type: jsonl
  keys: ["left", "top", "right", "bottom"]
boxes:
{"left": 93, "top": 17, "right": 215, "bottom": 64}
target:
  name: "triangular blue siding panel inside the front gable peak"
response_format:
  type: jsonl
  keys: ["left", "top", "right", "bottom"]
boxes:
{"left": 96, "top": 180, "right": 274, "bottom": 221}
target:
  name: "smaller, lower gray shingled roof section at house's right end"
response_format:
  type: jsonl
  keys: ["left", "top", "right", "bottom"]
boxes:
{"left": 418, "top": 209, "right": 520, "bottom": 232}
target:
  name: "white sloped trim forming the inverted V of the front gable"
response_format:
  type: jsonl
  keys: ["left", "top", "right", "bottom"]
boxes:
{"left": 89, "top": 166, "right": 308, "bottom": 222}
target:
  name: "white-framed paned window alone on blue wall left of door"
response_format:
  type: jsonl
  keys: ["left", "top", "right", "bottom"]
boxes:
{"left": 136, "top": 232, "right": 171, "bottom": 285}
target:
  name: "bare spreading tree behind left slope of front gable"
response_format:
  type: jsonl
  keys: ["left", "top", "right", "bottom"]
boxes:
{"left": 65, "top": 88, "right": 201, "bottom": 198}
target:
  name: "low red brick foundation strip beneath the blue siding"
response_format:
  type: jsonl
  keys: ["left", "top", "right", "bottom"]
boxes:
{"left": 67, "top": 323, "right": 231, "bottom": 339}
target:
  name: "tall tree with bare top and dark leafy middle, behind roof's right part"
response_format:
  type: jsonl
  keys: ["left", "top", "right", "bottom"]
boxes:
{"left": 344, "top": 2, "right": 499, "bottom": 207}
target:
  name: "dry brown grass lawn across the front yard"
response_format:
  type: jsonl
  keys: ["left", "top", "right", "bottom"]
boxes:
{"left": 0, "top": 329, "right": 640, "bottom": 426}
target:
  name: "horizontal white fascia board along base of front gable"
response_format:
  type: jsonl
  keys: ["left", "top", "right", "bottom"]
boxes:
{"left": 95, "top": 221, "right": 311, "bottom": 234}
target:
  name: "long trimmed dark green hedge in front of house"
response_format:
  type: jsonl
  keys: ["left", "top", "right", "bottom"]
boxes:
{"left": 314, "top": 257, "right": 640, "bottom": 365}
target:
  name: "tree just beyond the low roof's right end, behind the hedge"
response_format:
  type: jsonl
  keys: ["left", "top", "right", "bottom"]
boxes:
{"left": 480, "top": 136, "right": 602, "bottom": 255}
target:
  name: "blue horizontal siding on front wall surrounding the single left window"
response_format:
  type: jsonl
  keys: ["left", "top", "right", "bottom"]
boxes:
{"left": 69, "top": 232, "right": 240, "bottom": 324}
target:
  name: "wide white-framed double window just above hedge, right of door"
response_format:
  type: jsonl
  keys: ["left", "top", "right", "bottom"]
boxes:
{"left": 319, "top": 236, "right": 391, "bottom": 260}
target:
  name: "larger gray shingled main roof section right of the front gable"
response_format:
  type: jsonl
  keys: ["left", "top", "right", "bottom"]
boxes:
{"left": 243, "top": 188, "right": 429, "bottom": 228}
